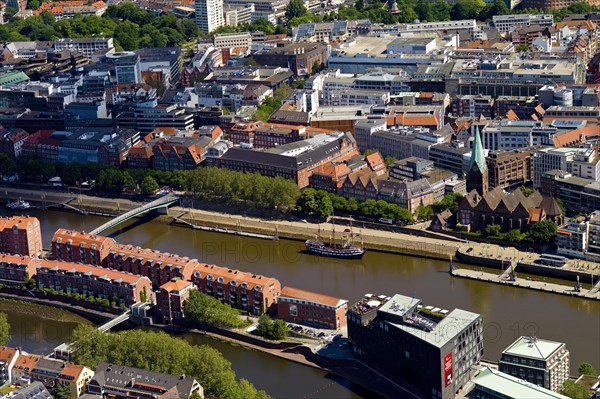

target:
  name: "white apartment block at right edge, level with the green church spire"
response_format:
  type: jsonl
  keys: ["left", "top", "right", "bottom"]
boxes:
{"left": 533, "top": 147, "right": 600, "bottom": 187}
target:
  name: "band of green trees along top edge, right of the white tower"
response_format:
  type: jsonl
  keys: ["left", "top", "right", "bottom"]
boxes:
{"left": 286, "top": 0, "right": 598, "bottom": 26}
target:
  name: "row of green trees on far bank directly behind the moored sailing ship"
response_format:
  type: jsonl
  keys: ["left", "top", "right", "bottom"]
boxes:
{"left": 296, "top": 188, "right": 413, "bottom": 223}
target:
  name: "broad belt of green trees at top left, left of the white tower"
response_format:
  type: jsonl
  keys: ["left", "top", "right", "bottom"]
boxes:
{"left": 0, "top": 2, "right": 200, "bottom": 50}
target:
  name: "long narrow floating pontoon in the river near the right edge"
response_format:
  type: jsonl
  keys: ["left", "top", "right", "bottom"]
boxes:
{"left": 450, "top": 268, "right": 600, "bottom": 300}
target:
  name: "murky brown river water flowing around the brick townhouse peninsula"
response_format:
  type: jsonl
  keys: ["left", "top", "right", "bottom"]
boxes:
{"left": 1, "top": 211, "right": 600, "bottom": 398}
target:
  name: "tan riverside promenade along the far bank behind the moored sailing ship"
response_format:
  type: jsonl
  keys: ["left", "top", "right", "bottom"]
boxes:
{"left": 0, "top": 187, "right": 600, "bottom": 285}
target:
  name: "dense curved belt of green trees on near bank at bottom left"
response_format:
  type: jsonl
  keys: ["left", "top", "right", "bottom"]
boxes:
{"left": 70, "top": 325, "right": 269, "bottom": 399}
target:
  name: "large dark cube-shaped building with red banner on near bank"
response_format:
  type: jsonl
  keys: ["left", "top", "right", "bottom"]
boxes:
{"left": 347, "top": 294, "right": 483, "bottom": 399}
